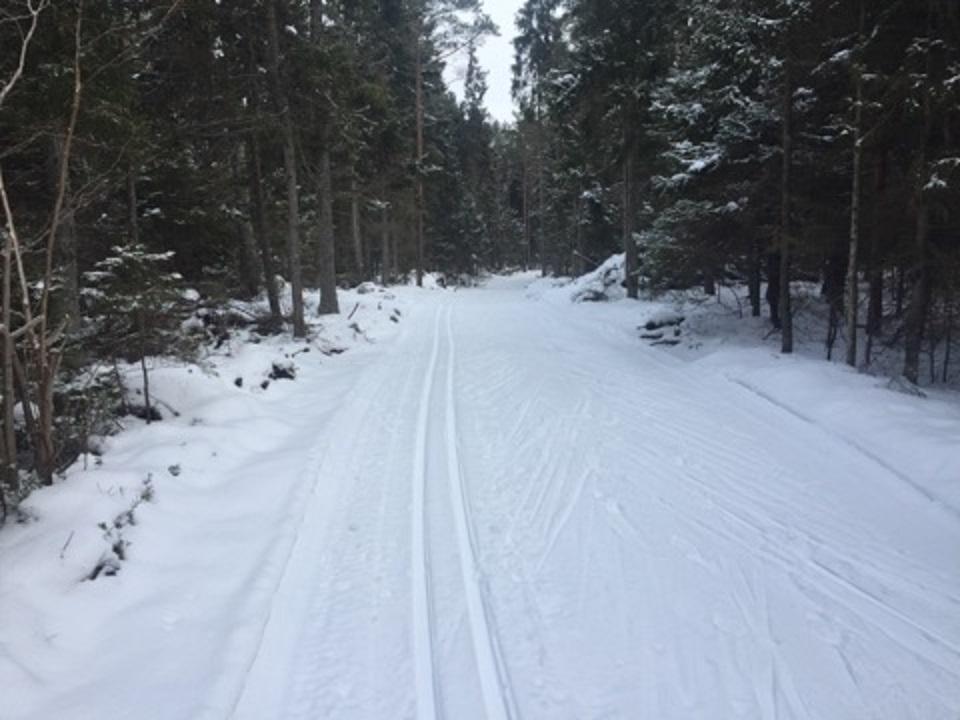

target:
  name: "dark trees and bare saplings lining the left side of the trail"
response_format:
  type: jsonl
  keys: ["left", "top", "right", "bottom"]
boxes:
{"left": 0, "top": 0, "right": 512, "bottom": 514}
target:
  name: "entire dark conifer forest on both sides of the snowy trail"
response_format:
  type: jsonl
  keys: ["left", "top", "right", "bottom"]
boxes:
{"left": 0, "top": 0, "right": 960, "bottom": 515}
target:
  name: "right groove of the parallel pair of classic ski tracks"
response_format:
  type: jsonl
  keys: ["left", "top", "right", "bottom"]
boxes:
{"left": 445, "top": 309, "right": 511, "bottom": 720}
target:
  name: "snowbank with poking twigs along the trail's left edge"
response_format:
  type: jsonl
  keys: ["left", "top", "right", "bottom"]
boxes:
{"left": 0, "top": 287, "right": 414, "bottom": 720}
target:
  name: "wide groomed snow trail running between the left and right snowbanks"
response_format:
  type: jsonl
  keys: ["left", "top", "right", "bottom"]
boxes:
{"left": 0, "top": 279, "right": 960, "bottom": 720}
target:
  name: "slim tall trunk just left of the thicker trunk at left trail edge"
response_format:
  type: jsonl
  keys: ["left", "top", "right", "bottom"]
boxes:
{"left": 267, "top": 0, "right": 307, "bottom": 337}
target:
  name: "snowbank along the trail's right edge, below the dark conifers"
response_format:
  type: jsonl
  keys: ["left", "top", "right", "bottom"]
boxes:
{"left": 527, "top": 255, "right": 960, "bottom": 518}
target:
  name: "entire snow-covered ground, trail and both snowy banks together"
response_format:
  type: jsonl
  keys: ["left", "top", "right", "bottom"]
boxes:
{"left": 0, "top": 274, "right": 960, "bottom": 720}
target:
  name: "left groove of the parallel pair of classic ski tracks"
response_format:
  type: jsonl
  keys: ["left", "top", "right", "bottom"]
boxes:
{"left": 410, "top": 309, "right": 441, "bottom": 720}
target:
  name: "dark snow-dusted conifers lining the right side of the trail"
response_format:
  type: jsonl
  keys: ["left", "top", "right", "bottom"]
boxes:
{"left": 515, "top": 0, "right": 960, "bottom": 382}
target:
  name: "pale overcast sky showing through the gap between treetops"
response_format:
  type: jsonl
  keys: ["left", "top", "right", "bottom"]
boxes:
{"left": 447, "top": 0, "right": 523, "bottom": 121}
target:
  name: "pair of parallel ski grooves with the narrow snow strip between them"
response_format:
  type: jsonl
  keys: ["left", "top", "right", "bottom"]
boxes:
{"left": 411, "top": 307, "right": 510, "bottom": 720}
